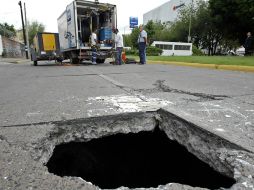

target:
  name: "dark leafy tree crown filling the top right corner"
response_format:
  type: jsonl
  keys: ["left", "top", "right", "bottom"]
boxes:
{"left": 209, "top": 0, "right": 254, "bottom": 43}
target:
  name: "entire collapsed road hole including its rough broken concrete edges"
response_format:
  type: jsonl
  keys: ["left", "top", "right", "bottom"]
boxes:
{"left": 32, "top": 109, "right": 254, "bottom": 189}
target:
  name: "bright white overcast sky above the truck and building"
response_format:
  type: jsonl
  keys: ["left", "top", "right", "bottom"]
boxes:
{"left": 0, "top": 0, "right": 169, "bottom": 33}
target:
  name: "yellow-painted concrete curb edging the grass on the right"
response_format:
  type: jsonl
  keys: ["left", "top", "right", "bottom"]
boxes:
{"left": 148, "top": 61, "right": 254, "bottom": 72}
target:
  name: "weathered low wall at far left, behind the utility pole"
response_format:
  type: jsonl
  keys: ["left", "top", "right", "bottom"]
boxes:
{"left": 1, "top": 36, "right": 25, "bottom": 58}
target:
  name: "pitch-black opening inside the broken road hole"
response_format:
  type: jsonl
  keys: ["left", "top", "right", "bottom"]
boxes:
{"left": 47, "top": 128, "right": 235, "bottom": 189}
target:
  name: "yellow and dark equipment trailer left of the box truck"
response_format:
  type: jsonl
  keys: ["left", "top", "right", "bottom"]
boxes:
{"left": 31, "top": 32, "right": 61, "bottom": 66}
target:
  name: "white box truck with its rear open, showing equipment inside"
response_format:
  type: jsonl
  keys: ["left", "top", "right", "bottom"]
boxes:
{"left": 58, "top": 0, "right": 117, "bottom": 64}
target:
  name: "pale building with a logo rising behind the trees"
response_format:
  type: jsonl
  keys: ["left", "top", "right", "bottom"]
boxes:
{"left": 143, "top": 0, "right": 192, "bottom": 24}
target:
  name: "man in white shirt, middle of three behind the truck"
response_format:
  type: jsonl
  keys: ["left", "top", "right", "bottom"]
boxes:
{"left": 113, "top": 28, "right": 123, "bottom": 65}
